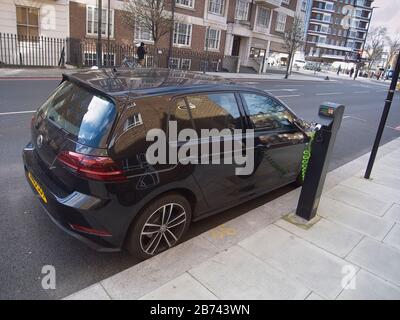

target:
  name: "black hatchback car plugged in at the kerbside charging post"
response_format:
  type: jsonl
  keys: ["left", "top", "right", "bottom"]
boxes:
{"left": 23, "top": 69, "right": 310, "bottom": 259}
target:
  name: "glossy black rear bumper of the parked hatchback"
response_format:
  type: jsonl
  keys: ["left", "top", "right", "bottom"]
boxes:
{"left": 22, "top": 144, "right": 123, "bottom": 252}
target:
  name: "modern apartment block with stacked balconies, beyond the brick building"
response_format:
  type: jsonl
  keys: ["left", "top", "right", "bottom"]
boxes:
{"left": 305, "top": 0, "right": 373, "bottom": 63}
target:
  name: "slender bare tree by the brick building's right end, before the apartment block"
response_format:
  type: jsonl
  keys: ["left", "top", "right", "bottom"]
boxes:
{"left": 284, "top": 15, "right": 304, "bottom": 79}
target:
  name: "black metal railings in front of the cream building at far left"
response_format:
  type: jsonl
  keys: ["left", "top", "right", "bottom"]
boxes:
{"left": 0, "top": 33, "right": 66, "bottom": 67}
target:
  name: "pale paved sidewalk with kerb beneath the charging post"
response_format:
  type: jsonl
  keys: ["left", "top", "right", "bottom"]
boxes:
{"left": 66, "top": 139, "right": 400, "bottom": 299}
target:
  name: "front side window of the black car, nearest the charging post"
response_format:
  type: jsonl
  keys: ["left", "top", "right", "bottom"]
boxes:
{"left": 241, "top": 93, "right": 295, "bottom": 131}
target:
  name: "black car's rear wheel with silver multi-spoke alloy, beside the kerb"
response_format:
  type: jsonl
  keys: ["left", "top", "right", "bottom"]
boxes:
{"left": 125, "top": 193, "right": 192, "bottom": 260}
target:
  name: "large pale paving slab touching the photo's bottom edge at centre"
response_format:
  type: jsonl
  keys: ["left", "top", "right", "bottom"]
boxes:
{"left": 189, "top": 246, "right": 311, "bottom": 300}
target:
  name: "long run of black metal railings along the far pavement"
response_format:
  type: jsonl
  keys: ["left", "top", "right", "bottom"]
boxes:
{"left": 0, "top": 33, "right": 227, "bottom": 72}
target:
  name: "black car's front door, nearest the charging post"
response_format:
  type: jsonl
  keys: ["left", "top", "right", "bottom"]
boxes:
{"left": 240, "top": 92, "right": 308, "bottom": 193}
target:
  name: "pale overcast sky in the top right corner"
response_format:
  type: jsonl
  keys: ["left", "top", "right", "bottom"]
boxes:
{"left": 371, "top": 0, "right": 400, "bottom": 37}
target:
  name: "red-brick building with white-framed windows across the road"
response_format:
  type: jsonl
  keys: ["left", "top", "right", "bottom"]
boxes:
{"left": 69, "top": 0, "right": 302, "bottom": 71}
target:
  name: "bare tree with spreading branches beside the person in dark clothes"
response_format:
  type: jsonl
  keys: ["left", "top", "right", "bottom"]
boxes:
{"left": 122, "top": 0, "right": 174, "bottom": 62}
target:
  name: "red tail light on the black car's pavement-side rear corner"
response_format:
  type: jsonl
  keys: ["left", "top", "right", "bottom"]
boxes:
{"left": 57, "top": 151, "right": 126, "bottom": 181}
